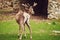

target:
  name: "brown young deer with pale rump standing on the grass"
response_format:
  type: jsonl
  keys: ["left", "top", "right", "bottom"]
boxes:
{"left": 16, "top": 3, "right": 37, "bottom": 40}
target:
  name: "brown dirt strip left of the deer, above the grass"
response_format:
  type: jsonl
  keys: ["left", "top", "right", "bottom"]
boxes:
{"left": 0, "top": 13, "right": 15, "bottom": 21}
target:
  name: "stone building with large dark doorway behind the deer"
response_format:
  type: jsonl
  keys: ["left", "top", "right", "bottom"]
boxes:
{"left": 0, "top": 0, "right": 60, "bottom": 19}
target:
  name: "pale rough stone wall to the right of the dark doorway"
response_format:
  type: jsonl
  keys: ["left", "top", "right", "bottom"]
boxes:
{"left": 48, "top": 0, "right": 60, "bottom": 19}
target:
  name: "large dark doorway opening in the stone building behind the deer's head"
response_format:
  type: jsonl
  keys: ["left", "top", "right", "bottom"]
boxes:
{"left": 19, "top": 0, "right": 48, "bottom": 18}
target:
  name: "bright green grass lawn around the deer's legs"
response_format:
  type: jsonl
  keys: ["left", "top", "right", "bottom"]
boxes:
{"left": 0, "top": 20, "right": 60, "bottom": 40}
